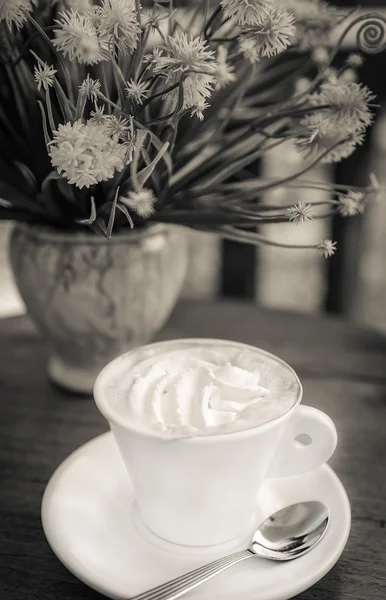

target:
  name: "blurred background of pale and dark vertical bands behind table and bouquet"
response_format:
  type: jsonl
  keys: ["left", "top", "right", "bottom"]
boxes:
{"left": 0, "top": 0, "right": 386, "bottom": 331}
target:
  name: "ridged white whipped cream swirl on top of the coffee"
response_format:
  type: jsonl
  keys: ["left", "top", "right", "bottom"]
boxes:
{"left": 126, "top": 348, "right": 268, "bottom": 435}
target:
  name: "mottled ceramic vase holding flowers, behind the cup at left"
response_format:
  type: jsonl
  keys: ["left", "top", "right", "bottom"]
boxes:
{"left": 10, "top": 223, "right": 187, "bottom": 393}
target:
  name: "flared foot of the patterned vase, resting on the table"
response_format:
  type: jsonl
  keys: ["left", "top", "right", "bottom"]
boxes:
{"left": 47, "top": 356, "right": 101, "bottom": 396}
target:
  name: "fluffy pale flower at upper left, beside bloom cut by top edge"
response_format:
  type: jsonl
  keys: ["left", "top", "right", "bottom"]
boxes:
{"left": 52, "top": 9, "right": 106, "bottom": 65}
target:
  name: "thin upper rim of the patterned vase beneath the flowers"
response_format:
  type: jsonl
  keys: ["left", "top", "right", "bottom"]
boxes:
{"left": 14, "top": 221, "right": 167, "bottom": 245}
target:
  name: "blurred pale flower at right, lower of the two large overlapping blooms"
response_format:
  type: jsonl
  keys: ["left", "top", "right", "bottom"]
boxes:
{"left": 295, "top": 112, "right": 364, "bottom": 163}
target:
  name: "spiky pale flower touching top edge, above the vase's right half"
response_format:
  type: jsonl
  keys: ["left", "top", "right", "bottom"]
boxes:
{"left": 96, "top": 0, "right": 141, "bottom": 54}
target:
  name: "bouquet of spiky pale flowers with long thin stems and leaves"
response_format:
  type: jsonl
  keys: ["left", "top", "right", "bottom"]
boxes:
{"left": 0, "top": 0, "right": 385, "bottom": 257}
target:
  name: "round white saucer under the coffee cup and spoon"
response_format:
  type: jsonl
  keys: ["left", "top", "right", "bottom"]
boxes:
{"left": 42, "top": 433, "right": 351, "bottom": 600}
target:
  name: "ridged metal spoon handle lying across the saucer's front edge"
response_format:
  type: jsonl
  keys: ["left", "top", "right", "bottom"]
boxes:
{"left": 130, "top": 550, "right": 255, "bottom": 600}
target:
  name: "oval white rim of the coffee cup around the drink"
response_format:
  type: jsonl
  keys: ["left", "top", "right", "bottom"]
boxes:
{"left": 93, "top": 337, "right": 303, "bottom": 444}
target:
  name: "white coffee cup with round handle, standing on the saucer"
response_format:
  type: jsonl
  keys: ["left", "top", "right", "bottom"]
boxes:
{"left": 94, "top": 339, "right": 337, "bottom": 546}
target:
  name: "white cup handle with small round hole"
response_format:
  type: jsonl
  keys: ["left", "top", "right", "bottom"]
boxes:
{"left": 267, "top": 405, "right": 338, "bottom": 478}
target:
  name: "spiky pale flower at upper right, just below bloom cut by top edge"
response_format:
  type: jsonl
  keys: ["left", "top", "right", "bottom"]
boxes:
{"left": 240, "top": 7, "right": 295, "bottom": 62}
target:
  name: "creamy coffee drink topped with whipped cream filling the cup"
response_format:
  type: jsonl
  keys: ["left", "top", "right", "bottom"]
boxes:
{"left": 104, "top": 339, "right": 301, "bottom": 438}
